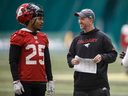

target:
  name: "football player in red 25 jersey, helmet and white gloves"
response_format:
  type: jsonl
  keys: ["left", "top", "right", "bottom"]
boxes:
{"left": 9, "top": 3, "right": 54, "bottom": 96}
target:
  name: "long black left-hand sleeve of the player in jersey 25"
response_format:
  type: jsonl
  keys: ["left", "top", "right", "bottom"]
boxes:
{"left": 9, "top": 44, "right": 21, "bottom": 81}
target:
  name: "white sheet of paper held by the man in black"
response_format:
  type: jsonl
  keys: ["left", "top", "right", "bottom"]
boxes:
{"left": 74, "top": 55, "right": 97, "bottom": 74}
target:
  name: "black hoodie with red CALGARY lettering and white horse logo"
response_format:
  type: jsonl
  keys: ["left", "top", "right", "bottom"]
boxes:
{"left": 67, "top": 28, "right": 117, "bottom": 90}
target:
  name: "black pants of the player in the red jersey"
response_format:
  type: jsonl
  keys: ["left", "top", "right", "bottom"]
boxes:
{"left": 15, "top": 81, "right": 46, "bottom": 96}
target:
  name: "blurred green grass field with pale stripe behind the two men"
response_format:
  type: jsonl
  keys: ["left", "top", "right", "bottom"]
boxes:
{"left": 0, "top": 54, "right": 128, "bottom": 96}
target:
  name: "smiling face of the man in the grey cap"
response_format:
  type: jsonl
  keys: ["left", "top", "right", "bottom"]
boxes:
{"left": 78, "top": 16, "right": 92, "bottom": 29}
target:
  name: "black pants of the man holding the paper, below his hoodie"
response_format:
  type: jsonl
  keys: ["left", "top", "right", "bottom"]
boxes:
{"left": 73, "top": 87, "right": 110, "bottom": 96}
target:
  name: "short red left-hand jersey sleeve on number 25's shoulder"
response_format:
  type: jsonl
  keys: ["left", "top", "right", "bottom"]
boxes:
{"left": 10, "top": 31, "right": 23, "bottom": 46}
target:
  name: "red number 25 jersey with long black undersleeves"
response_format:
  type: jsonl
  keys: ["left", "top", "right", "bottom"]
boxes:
{"left": 9, "top": 28, "right": 53, "bottom": 94}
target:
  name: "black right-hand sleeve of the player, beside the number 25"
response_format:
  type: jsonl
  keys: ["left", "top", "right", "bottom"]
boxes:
{"left": 44, "top": 47, "right": 53, "bottom": 81}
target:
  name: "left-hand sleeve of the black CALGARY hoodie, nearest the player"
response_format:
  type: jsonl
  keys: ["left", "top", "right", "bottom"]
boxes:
{"left": 67, "top": 39, "right": 76, "bottom": 68}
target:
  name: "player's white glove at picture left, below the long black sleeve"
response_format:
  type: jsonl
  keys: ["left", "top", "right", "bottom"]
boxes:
{"left": 13, "top": 81, "right": 25, "bottom": 95}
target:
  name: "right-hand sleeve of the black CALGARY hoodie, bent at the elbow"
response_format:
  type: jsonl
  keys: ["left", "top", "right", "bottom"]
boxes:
{"left": 101, "top": 37, "right": 117, "bottom": 63}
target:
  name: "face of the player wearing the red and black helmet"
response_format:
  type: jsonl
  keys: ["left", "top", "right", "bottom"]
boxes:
{"left": 33, "top": 17, "right": 44, "bottom": 31}
